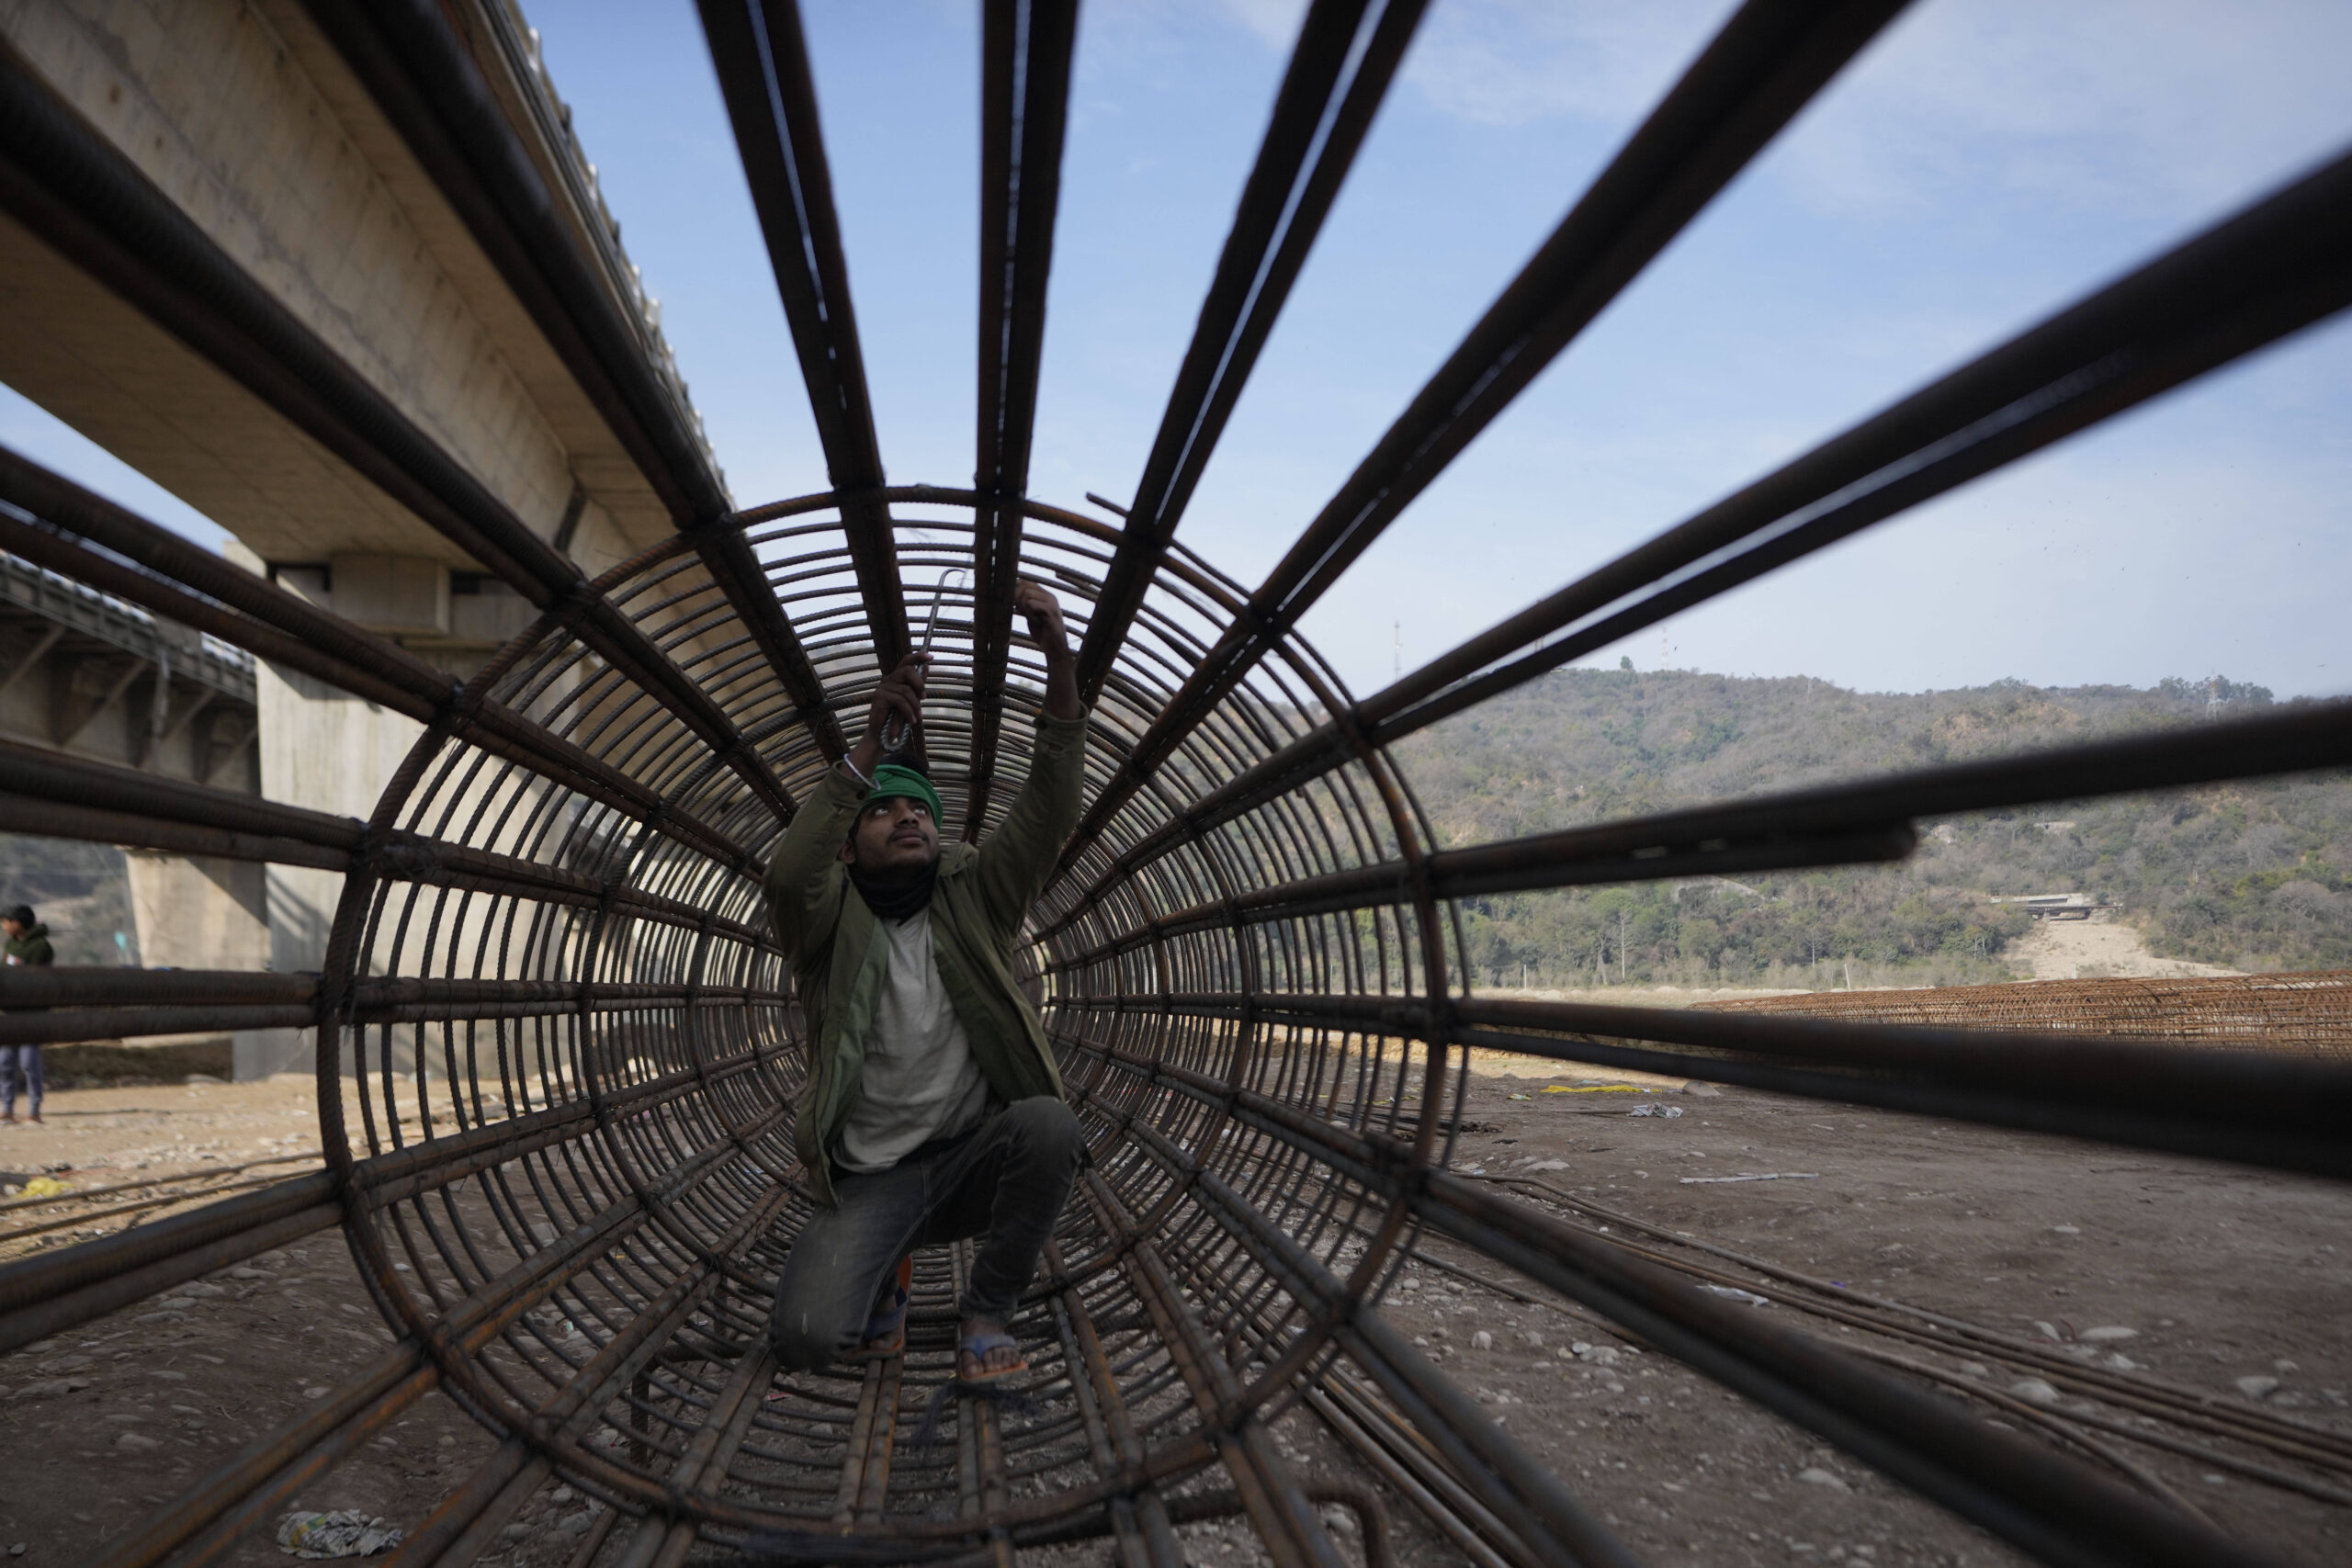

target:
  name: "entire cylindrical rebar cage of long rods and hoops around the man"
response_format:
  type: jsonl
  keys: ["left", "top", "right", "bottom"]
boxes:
{"left": 0, "top": 0, "right": 2352, "bottom": 1568}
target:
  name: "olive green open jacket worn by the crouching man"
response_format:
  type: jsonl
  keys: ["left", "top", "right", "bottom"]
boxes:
{"left": 767, "top": 717, "right": 1087, "bottom": 1206}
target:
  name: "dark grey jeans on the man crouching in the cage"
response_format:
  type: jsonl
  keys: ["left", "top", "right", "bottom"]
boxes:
{"left": 767, "top": 1098, "right": 1082, "bottom": 1371}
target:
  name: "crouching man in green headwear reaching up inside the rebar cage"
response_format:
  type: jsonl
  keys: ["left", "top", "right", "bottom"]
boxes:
{"left": 767, "top": 583, "right": 1087, "bottom": 1382}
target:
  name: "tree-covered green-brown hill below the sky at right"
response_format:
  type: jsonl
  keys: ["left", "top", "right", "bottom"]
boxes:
{"left": 1397, "top": 670, "right": 2352, "bottom": 985}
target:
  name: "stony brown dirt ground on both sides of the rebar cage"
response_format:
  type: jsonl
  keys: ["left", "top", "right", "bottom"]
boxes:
{"left": 0, "top": 1081, "right": 2352, "bottom": 1568}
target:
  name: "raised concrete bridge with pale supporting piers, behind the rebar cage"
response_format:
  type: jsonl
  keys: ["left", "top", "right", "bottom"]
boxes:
{"left": 0, "top": 0, "right": 729, "bottom": 1072}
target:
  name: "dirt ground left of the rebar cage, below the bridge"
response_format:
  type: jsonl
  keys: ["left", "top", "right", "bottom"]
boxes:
{"left": 0, "top": 1075, "right": 510, "bottom": 1568}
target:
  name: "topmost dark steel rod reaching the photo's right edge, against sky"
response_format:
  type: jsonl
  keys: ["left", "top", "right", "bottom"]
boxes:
{"left": 1122, "top": 143, "right": 2352, "bottom": 867}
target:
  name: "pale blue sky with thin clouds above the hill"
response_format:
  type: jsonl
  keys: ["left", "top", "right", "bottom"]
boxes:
{"left": 0, "top": 0, "right": 2352, "bottom": 696}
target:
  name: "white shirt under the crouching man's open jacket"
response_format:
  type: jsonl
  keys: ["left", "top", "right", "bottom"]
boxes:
{"left": 840, "top": 909, "right": 988, "bottom": 1176}
